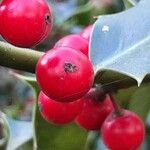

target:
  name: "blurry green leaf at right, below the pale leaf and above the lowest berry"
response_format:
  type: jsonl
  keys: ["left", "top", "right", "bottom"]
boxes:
{"left": 115, "top": 83, "right": 150, "bottom": 122}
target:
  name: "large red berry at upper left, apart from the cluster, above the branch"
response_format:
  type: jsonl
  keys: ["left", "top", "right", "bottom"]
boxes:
{"left": 0, "top": 0, "right": 52, "bottom": 47}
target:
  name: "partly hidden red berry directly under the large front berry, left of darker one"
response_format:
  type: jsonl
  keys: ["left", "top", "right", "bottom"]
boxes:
{"left": 38, "top": 92, "right": 83, "bottom": 124}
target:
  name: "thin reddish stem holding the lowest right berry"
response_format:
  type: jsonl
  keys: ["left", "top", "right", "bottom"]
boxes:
{"left": 109, "top": 93, "right": 122, "bottom": 116}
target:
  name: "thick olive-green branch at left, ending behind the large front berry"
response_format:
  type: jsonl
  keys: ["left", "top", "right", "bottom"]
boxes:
{"left": 0, "top": 41, "right": 44, "bottom": 73}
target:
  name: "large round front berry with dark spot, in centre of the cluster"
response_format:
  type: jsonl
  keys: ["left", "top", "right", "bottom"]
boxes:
{"left": 36, "top": 47, "right": 94, "bottom": 102}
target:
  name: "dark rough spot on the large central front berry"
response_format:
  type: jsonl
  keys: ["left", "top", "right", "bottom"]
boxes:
{"left": 64, "top": 62, "right": 78, "bottom": 73}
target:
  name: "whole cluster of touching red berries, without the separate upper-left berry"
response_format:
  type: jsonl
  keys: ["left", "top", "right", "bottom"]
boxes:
{"left": 36, "top": 26, "right": 145, "bottom": 150}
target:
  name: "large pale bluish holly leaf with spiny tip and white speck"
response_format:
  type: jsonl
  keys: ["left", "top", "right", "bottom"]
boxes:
{"left": 90, "top": 0, "right": 150, "bottom": 85}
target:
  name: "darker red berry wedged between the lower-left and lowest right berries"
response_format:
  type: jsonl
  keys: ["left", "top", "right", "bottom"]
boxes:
{"left": 76, "top": 88, "right": 113, "bottom": 130}
